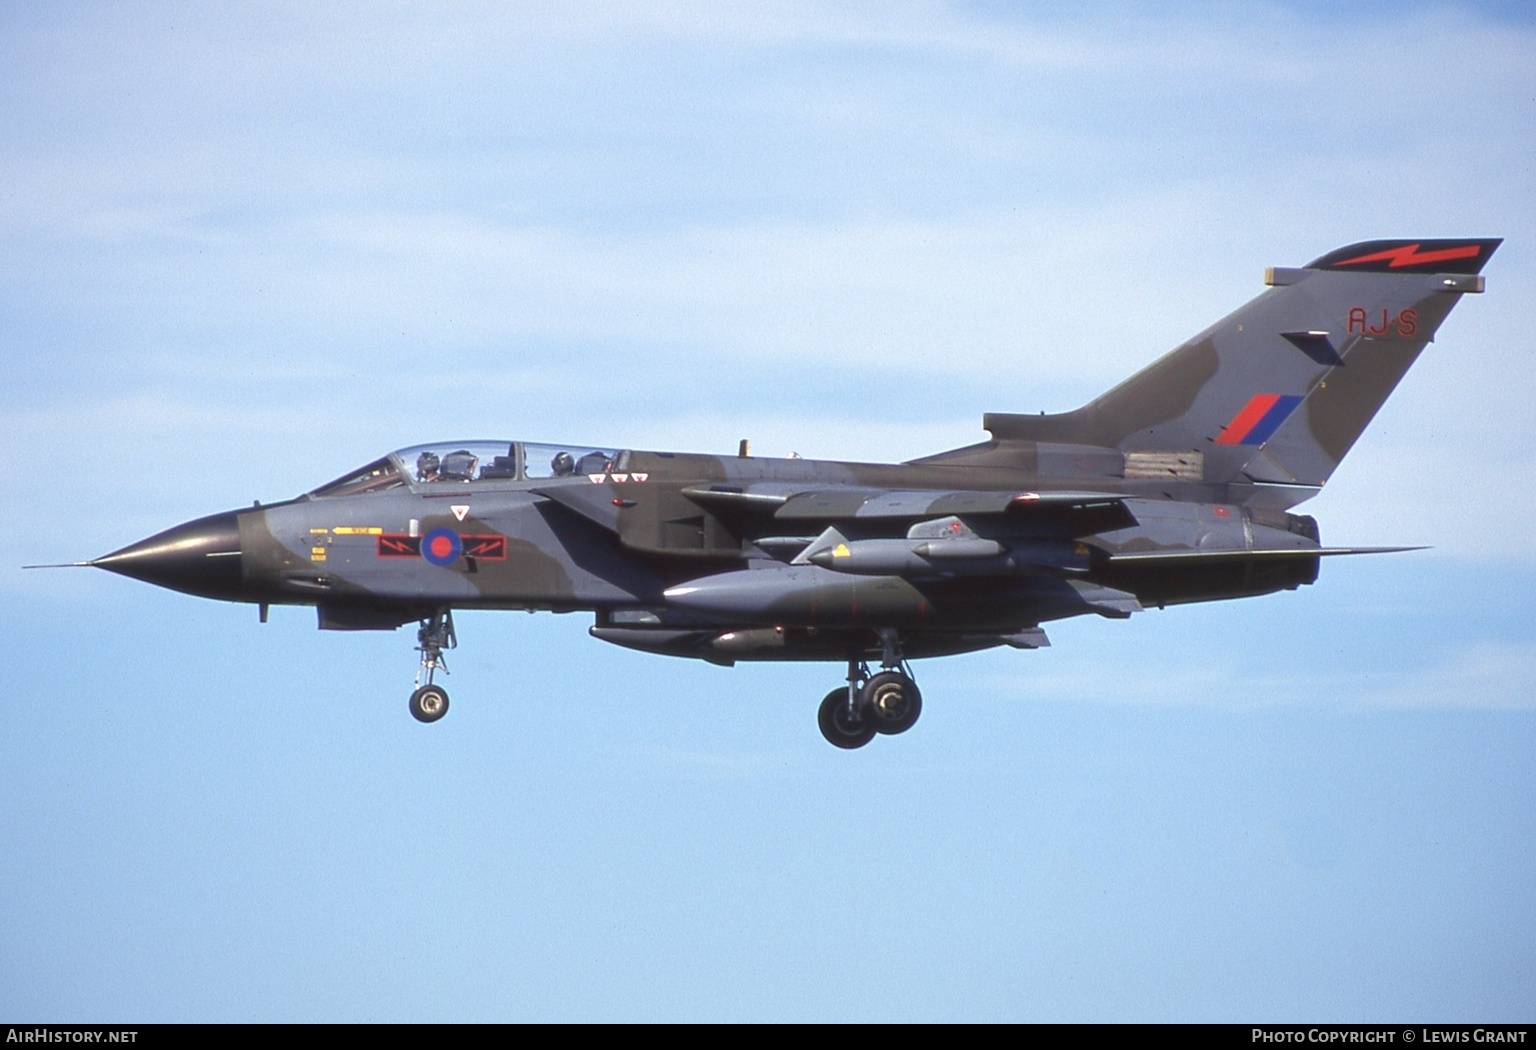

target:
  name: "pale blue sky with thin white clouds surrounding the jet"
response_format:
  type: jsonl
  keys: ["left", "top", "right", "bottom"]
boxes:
{"left": 0, "top": 3, "right": 1536, "bottom": 1021}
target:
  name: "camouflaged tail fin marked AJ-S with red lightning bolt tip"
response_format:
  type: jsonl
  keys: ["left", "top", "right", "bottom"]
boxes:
{"left": 983, "top": 238, "right": 1501, "bottom": 485}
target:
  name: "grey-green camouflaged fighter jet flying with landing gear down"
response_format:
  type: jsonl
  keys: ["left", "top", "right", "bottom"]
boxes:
{"left": 62, "top": 239, "right": 1499, "bottom": 748}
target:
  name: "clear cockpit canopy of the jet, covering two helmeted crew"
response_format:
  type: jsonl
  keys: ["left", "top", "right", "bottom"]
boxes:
{"left": 310, "top": 441, "right": 621, "bottom": 499}
